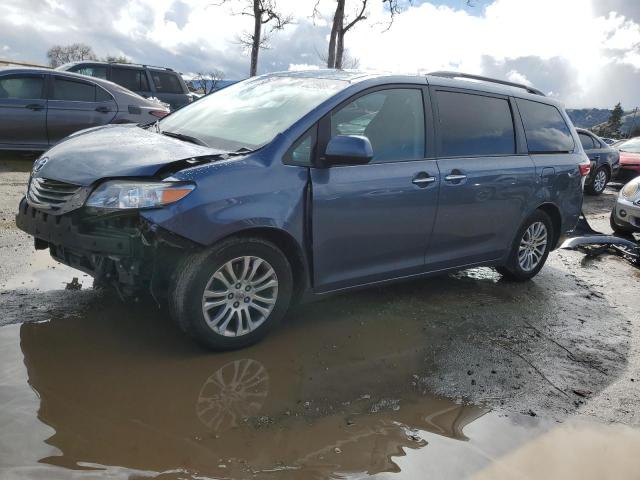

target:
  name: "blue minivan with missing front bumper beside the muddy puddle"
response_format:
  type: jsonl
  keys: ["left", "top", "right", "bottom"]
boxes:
{"left": 16, "top": 70, "right": 590, "bottom": 349}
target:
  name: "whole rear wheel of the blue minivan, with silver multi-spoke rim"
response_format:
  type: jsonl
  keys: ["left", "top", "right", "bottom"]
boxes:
{"left": 496, "top": 210, "right": 555, "bottom": 282}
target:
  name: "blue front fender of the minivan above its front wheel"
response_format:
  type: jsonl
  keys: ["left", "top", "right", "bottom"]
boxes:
{"left": 141, "top": 156, "right": 308, "bottom": 246}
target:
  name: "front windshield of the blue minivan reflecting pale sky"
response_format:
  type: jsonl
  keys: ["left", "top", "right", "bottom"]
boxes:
{"left": 160, "top": 75, "right": 348, "bottom": 150}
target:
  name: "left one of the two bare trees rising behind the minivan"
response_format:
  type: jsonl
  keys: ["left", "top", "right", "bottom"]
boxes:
{"left": 217, "top": 0, "right": 293, "bottom": 77}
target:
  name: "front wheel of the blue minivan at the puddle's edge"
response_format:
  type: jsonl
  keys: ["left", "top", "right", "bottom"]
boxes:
{"left": 169, "top": 238, "right": 293, "bottom": 350}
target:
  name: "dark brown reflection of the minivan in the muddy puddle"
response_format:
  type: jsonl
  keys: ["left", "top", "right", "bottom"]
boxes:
{"left": 20, "top": 305, "right": 486, "bottom": 478}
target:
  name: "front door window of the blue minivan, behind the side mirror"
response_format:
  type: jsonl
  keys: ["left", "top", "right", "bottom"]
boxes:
{"left": 331, "top": 88, "right": 425, "bottom": 162}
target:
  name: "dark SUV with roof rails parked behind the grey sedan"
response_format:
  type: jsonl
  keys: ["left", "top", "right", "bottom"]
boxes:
{"left": 56, "top": 61, "right": 198, "bottom": 110}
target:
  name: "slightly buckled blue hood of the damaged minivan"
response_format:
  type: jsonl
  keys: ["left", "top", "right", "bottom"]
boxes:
{"left": 35, "top": 124, "right": 224, "bottom": 186}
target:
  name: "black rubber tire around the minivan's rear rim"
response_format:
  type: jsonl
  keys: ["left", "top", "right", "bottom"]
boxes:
{"left": 496, "top": 210, "right": 555, "bottom": 282}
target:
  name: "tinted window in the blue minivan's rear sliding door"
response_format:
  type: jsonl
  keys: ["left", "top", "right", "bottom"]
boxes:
{"left": 437, "top": 91, "right": 516, "bottom": 157}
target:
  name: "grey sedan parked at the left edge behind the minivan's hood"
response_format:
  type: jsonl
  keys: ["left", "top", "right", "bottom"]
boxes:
{"left": 0, "top": 68, "right": 168, "bottom": 150}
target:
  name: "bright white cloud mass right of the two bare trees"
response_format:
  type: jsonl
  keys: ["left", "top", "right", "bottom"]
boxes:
{"left": 347, "top": 0, "right": 640, "bottom": 105}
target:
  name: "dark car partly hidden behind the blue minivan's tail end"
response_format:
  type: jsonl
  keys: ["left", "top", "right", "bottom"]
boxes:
{"left": 576, "top": 128, "right": 620, "bottom": 195}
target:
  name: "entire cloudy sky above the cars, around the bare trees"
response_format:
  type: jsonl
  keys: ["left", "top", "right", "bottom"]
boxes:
{"left": 0, "top": 0, "right": 640, "bottom": 106}
